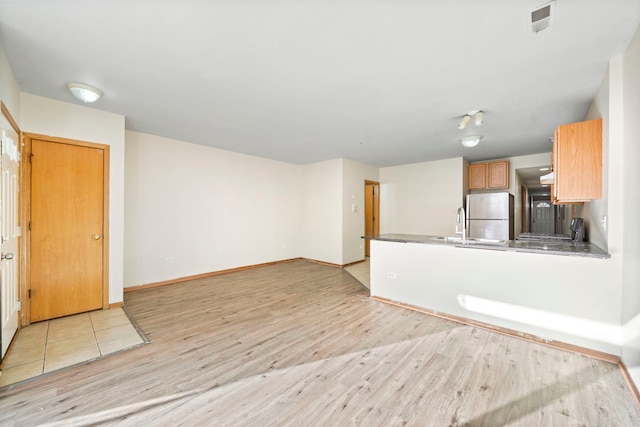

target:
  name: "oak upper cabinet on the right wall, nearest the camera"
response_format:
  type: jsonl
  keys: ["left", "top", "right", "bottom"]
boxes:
{"left": 551, "top": 119, "right": 602, "bottom": 204}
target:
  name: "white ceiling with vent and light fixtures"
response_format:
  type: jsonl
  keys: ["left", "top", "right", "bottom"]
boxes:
{"left": 0, "top": 0, "right": 640, "bottom": 166}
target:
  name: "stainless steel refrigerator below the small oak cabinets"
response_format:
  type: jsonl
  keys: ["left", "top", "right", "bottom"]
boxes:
{"left": 466, "top": 191, "right": 513, "bottom": 240}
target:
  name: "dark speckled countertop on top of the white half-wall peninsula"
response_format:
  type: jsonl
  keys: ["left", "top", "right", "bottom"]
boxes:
{"left": 363, "top": 233, "right": 611, "bottom": 259}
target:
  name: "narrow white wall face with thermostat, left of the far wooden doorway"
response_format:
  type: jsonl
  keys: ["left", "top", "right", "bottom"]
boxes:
{"left": 342, "top": 159, "right": 379, "bottom": 265}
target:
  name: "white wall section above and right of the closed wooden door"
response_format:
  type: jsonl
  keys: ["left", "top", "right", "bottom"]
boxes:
{"left": 20, "top": 93, "right": 124, "bottom": 304}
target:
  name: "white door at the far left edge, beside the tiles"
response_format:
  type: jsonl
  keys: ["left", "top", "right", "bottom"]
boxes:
{"left": 0, "top": 125, "right": 20, "bottom": 359}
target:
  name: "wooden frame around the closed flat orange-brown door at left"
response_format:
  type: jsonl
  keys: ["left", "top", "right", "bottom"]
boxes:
{"left": 21, "top": 133, "right": 110, "bottom": 326}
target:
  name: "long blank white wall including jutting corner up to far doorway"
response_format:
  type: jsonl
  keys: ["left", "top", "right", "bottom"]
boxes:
{"left": 125, "top": 139, "right": 378, "bottom": 286}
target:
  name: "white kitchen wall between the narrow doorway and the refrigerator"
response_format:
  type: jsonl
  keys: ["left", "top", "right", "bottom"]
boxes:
{"left": 380, "top": 157, "right": 465, "bottom": 236}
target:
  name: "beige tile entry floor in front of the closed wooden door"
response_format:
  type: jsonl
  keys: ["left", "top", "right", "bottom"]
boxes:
{"left": 0, "top": 308, "right": 145, "bottom": 387}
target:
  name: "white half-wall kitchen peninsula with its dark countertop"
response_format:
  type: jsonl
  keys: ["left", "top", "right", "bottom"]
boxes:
{"left": 365, "top": 234, "right": 621, "bottom": 359}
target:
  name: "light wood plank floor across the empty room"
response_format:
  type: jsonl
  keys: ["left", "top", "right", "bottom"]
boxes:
{"left": 0, "top": 261, "right": 640, "bottom": 426}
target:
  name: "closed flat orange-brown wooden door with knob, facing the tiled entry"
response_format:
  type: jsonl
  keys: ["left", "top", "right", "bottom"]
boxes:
{"left": 30, "top": 139, "right": 105, "bottom": 322}
